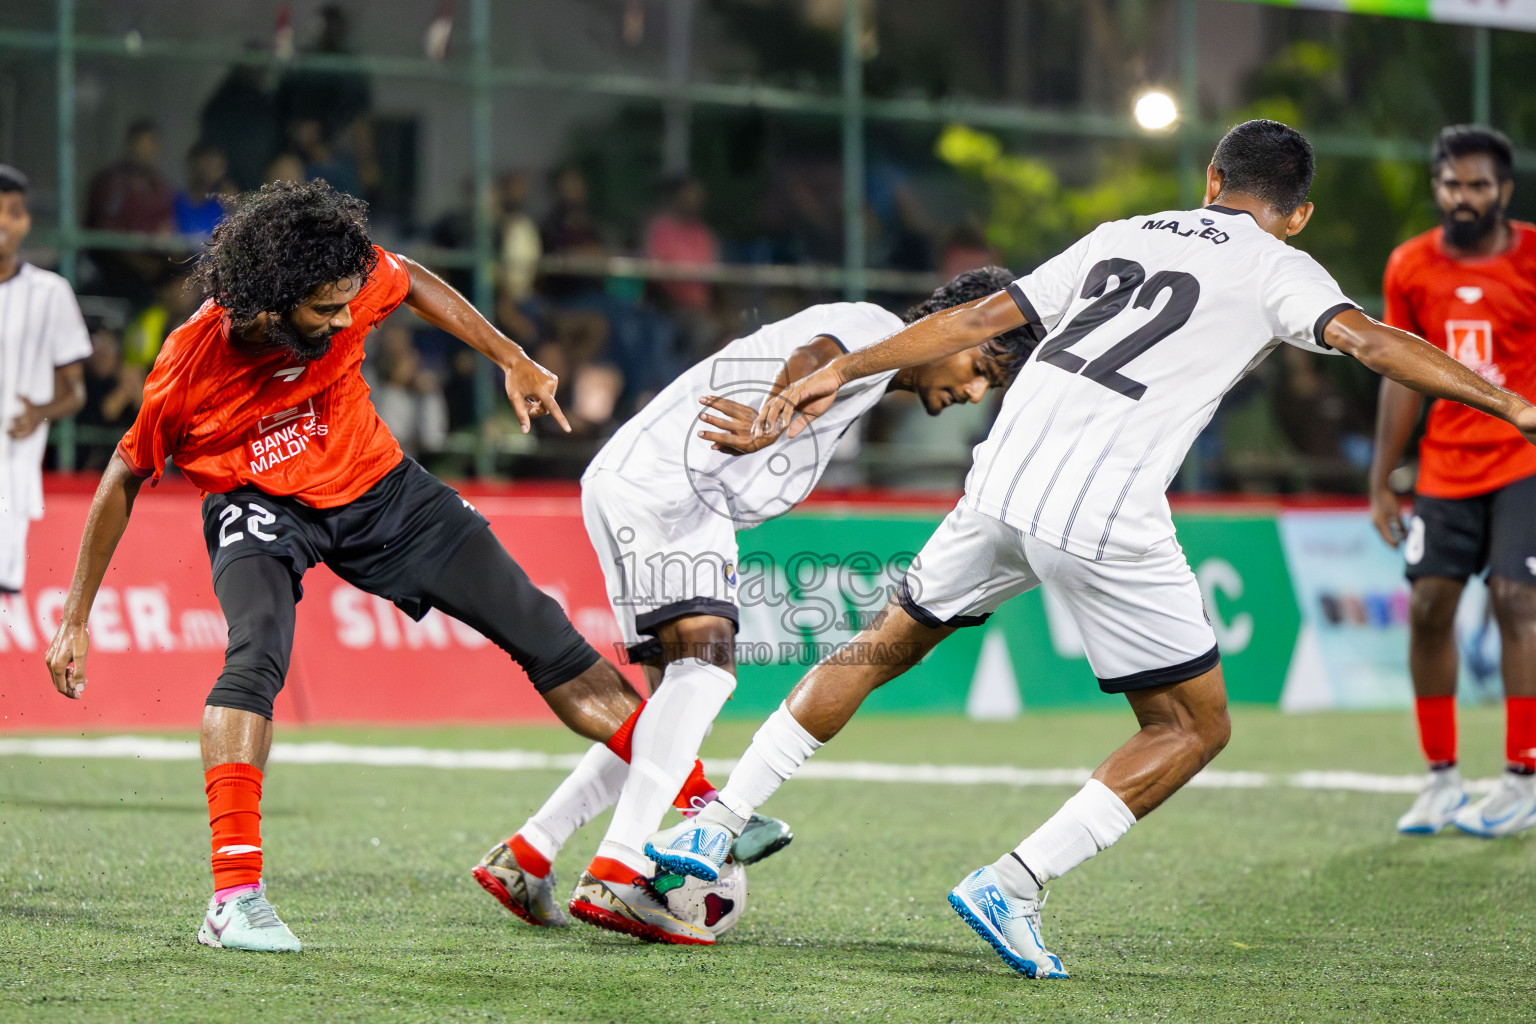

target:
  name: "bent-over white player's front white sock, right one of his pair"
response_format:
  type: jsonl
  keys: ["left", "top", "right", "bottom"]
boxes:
{"left": 599, "top": 657, "right": 736, "bottom": 870}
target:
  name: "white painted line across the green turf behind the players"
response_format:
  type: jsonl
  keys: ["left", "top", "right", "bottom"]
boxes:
{"left": 0, "top": 735, "right": 1495, "bottom": 794}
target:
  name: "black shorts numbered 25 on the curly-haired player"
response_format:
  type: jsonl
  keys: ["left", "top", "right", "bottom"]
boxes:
{"left": 203, "top": 459, "right": 488, "bottom": 620}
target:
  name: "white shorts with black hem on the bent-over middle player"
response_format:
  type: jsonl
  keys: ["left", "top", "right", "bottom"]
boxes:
{"left": 581, "top": 470, "right": 740, "bottom": 662}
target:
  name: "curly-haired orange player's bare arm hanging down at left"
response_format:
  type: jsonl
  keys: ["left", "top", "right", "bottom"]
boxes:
{"left": 45, "top": 451, "right": 144, "bottom": 697}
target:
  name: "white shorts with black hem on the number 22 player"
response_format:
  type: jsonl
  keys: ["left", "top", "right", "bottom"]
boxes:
{"left": 897, "top": 505, "right": 1221, "bottom": 694}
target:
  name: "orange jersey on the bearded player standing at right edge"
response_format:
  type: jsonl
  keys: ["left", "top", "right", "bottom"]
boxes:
{"left": 1382, "top": 221, "right": 1536, "bottom": 497}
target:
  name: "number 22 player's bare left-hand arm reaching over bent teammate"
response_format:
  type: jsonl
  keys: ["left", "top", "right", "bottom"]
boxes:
{"left": 753, "top": 292, "right": 1025, "bottom": 438}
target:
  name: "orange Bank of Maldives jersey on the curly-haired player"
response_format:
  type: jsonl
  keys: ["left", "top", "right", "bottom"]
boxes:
{"left": 117, "top": 247, "right": 410, "bottom": 508}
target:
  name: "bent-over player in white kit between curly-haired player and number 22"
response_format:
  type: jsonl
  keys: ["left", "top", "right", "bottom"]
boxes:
{"left": 473, "top": 267, "right": 1037, "bottom": 944}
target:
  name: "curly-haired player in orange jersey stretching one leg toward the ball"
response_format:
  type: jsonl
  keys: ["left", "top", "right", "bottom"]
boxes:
{"left": 46, "top": 181, "right": 672, "bottom": 952}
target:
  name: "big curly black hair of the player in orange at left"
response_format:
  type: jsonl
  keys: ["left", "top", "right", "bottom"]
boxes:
{"left": 192, "top": 180, "right": 378, "bottom": 324}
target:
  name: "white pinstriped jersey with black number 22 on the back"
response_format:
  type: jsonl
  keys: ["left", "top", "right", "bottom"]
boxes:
{"left": 965, "top": 206, "right": 1356, "bottom": 560}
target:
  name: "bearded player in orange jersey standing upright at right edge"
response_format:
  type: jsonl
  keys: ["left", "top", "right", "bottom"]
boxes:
{"left": 1370, "top": 124, "right": 1536, "bottom": 838}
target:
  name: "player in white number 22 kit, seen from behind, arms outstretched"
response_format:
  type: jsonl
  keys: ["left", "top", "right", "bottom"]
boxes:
{"left": 645, "top": 121, "right": 1536, "bottom": 978}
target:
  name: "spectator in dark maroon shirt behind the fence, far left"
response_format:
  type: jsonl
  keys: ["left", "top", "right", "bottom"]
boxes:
{"left": 84, "top": 120, "right": 177, "bottom": 307}
